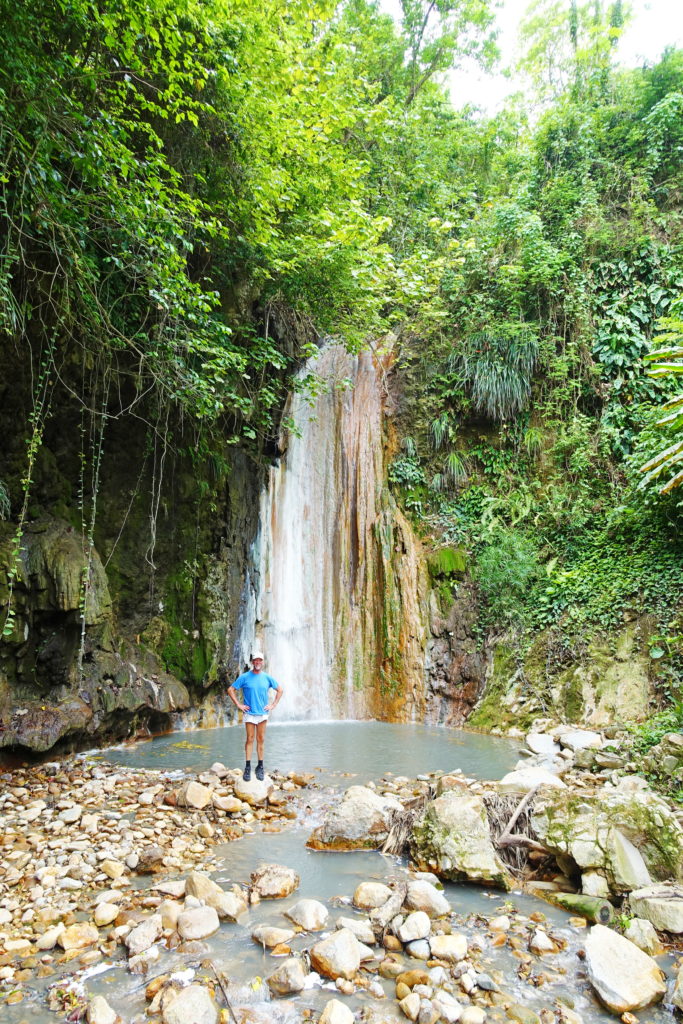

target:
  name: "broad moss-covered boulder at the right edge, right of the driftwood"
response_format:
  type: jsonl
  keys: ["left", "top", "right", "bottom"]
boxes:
{"left": 531, "top": 779, "right": 683, "bottom": 894}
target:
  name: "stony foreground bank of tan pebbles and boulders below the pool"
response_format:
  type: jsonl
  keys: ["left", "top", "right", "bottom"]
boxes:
{"left": 0, "top": 727, "right": 683, "bottom": 1024}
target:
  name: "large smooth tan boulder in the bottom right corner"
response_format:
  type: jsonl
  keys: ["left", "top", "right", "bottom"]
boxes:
{"left": 586, "top": 925, "right": 667, "bottom": 1014}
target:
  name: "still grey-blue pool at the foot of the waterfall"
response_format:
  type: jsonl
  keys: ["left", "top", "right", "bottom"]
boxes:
{"left": 102, "top": 722, "right": 519, "bottom": 784}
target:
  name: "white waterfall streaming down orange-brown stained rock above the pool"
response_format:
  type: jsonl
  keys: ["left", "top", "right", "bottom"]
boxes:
{"left": 256, "top": 344, "right": 425, "bottom": 720}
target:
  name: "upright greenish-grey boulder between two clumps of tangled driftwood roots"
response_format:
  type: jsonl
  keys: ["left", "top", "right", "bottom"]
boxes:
{"left": 411, "top": 791, "right": 511, "bottom": 890}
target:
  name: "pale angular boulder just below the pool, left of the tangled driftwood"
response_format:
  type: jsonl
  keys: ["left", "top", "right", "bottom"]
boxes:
{"left": 306, "top": 785, "right": 402, "bottom": 850}
